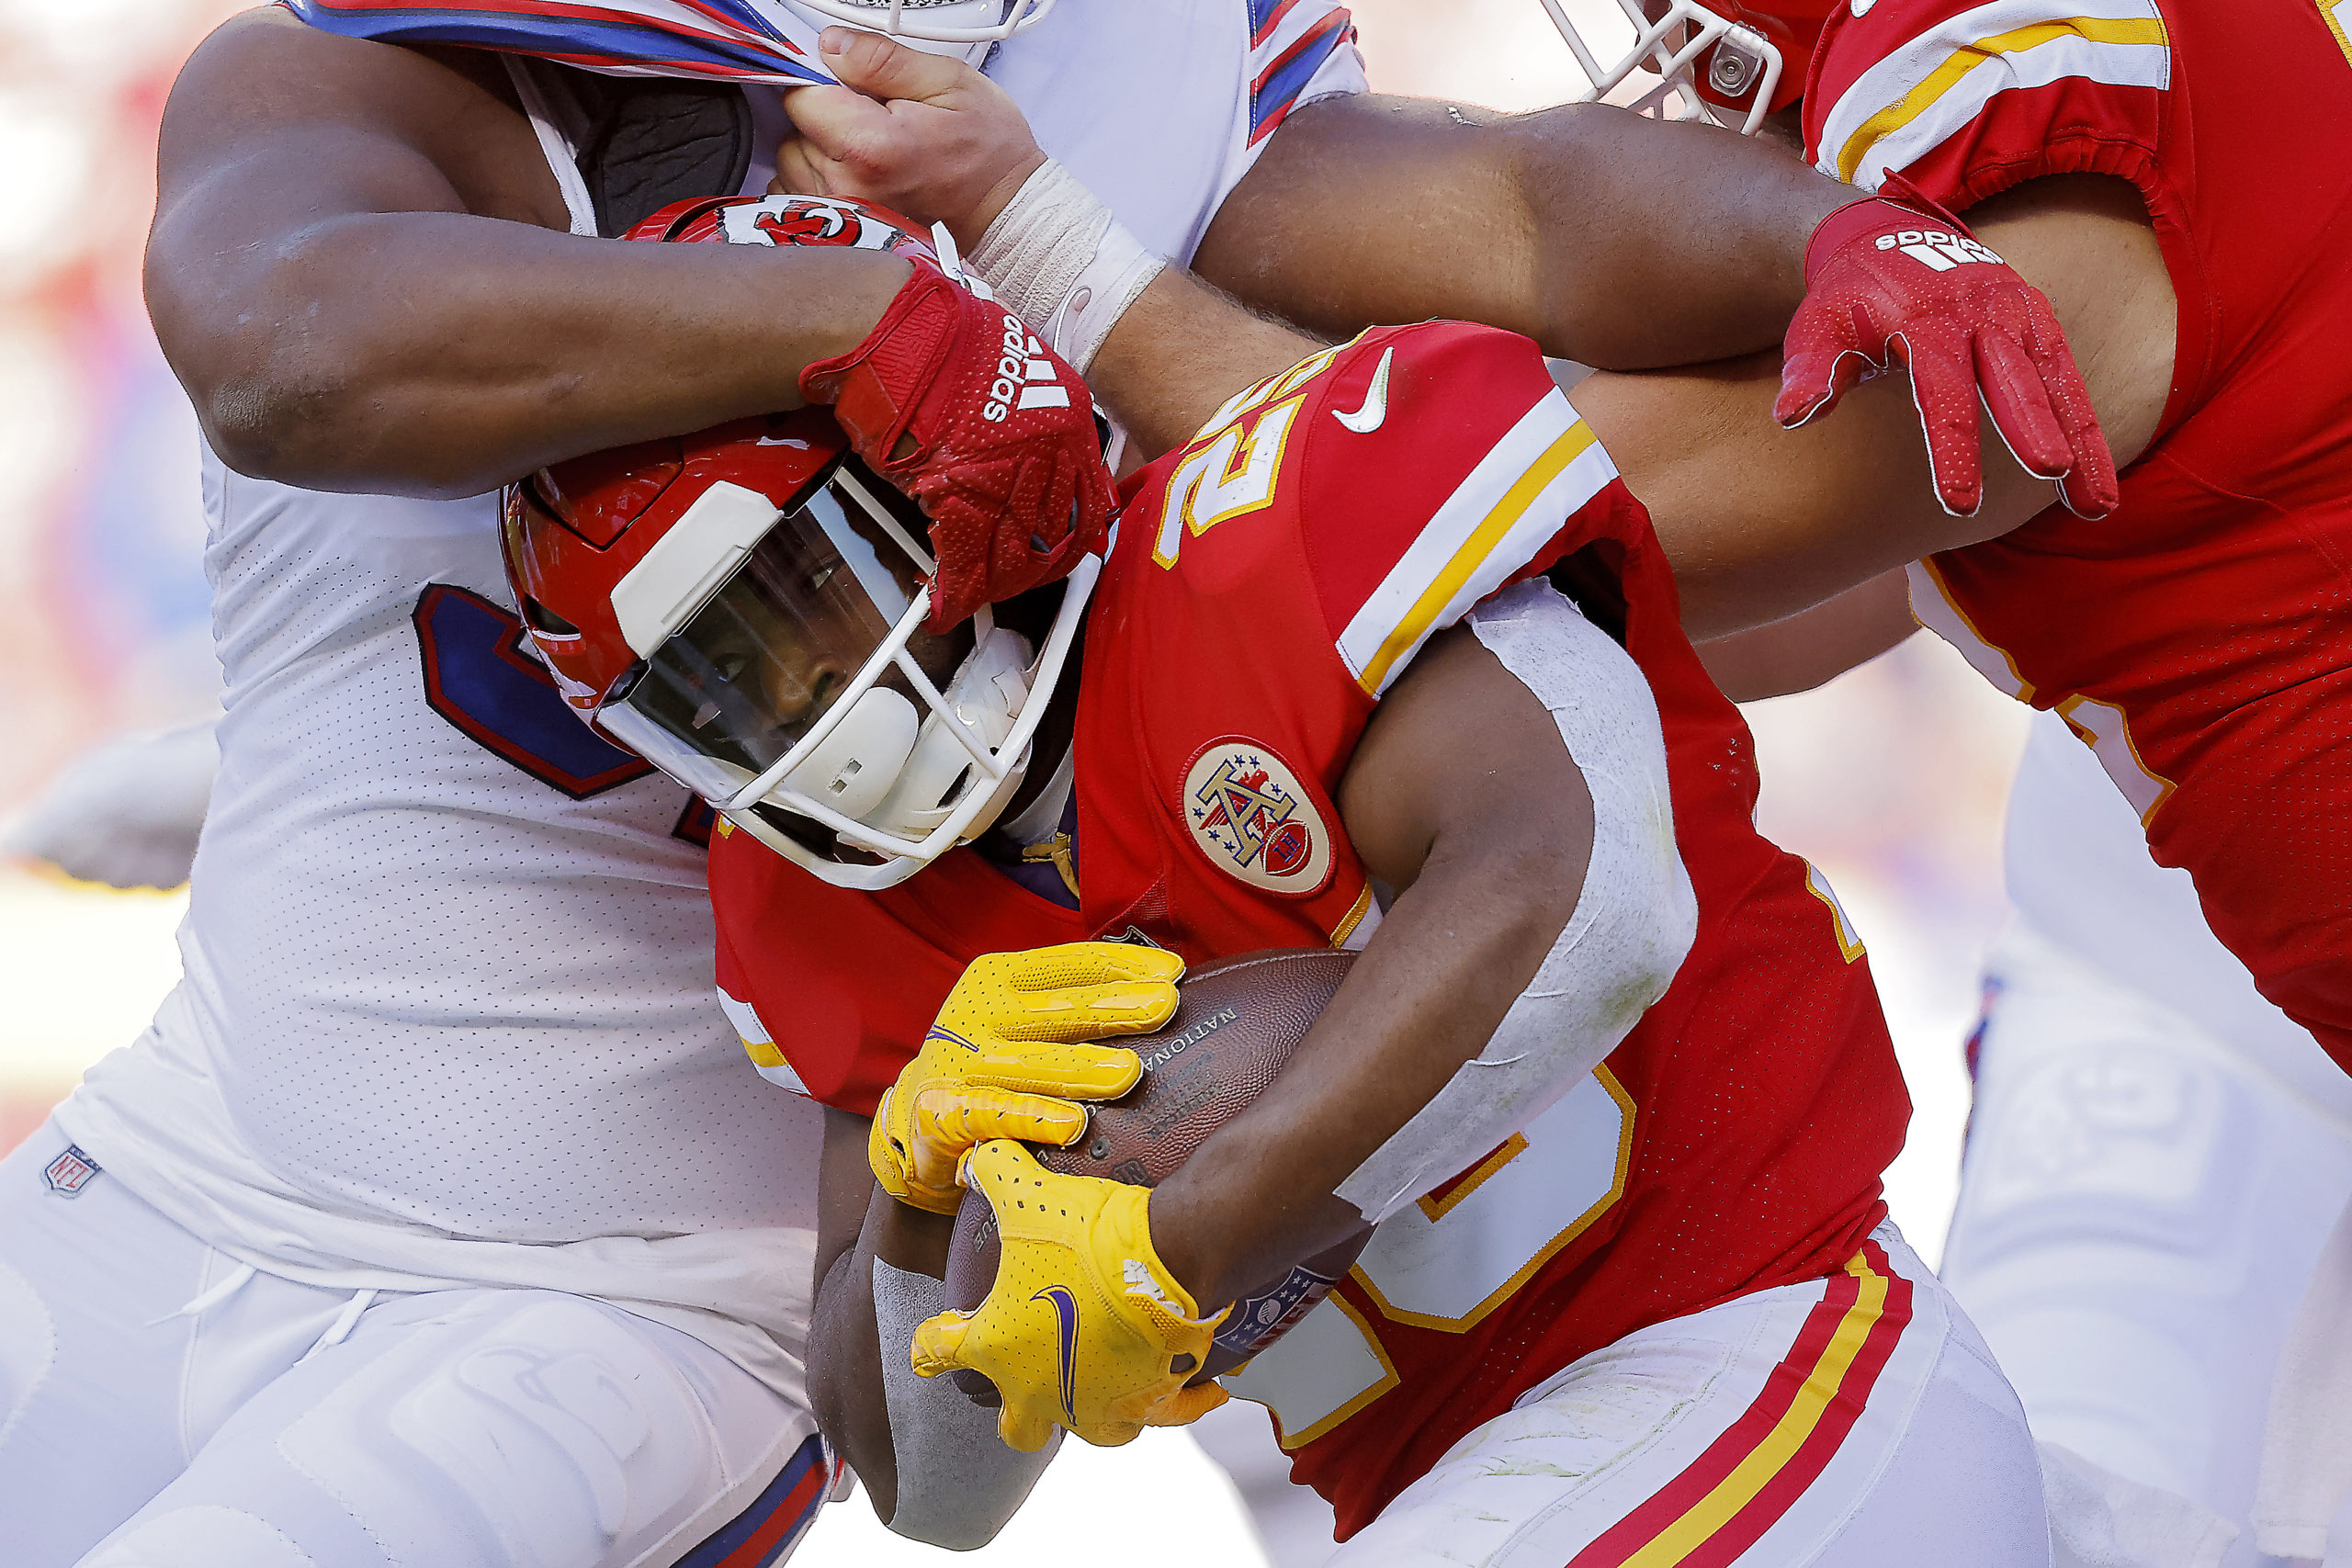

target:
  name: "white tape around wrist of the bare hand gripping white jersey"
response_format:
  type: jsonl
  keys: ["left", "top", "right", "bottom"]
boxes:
{"left": 969, "top": 157, "right": 1167, "bottom": 374}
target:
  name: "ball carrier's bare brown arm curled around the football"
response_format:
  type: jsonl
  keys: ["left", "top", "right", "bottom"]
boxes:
{"left": 1150, "top": 627, "right": 1595, "bottom": 1307}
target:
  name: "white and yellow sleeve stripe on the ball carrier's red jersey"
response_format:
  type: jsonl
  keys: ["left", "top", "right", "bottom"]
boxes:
{"left": 1339, "top": 390, "right": 1618, "bottom": 696}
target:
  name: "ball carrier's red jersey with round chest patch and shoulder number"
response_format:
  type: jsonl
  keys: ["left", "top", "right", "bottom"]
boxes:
{"left": 710, "top": 324, "right": 1910, "bottom": 1535}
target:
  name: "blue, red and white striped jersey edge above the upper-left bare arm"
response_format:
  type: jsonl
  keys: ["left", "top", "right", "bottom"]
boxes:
{"left": 277, "top": 0, "right": 832, "bottom": 87}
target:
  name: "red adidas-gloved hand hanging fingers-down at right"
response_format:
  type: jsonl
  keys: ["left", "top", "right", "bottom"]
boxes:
{"left": 1773, "top": 181, "right": 2121, "bottom": 517}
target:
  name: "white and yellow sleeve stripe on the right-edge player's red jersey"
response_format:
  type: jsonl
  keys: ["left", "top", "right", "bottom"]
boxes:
{"left": 1815, "top": 0, "right": 2173, "bottom": 190}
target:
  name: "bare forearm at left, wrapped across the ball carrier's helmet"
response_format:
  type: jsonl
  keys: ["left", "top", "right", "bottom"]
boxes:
{"left": 148, "top": 211, "right": 908, "bottom": 496}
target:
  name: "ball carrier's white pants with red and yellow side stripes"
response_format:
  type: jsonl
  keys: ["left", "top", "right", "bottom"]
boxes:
{"left": 1223, "top": 1224, "right": 2049, "bottom": 1568}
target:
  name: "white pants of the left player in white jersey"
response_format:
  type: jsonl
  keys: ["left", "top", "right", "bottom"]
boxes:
{"left": 0, "top": 1126, "right": 832, "bottom": 1568}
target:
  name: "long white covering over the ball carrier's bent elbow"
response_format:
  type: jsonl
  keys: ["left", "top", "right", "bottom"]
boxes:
{"left": 1339, "top": 579, "right": 1698, "bottom": 1223}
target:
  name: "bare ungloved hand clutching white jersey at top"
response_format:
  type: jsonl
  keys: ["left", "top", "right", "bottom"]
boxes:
{"left": 769, "top": 28, "right": 1045, "bottom": 249}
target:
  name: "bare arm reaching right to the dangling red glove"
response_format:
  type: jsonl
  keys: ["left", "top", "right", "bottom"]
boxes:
{"left": 1194, "top": 98, "right": 1856, "bottom": 369}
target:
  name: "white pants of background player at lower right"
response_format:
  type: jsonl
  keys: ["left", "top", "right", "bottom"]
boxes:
{"left": 1943, "top": 933, "right": 2352, "bottom": 1568}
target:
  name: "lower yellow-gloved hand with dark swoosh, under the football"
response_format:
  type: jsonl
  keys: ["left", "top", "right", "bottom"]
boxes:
{"left": 912, "top": 1140, "right": 1230, "bottom": 1453}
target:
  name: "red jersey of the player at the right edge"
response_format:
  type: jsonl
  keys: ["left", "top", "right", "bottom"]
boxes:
{"left": 1804, "top": 0, "right": 2352, "bottom": 1065}
